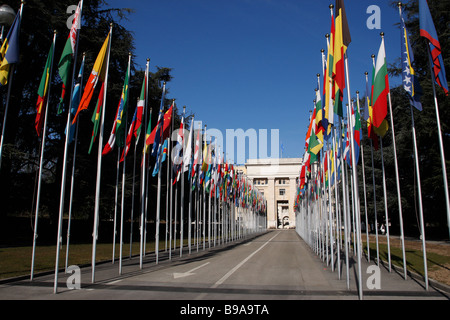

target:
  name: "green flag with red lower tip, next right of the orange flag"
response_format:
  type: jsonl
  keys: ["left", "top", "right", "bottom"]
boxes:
{"left": 102, "top": 58, "right": 131, "bottom": 155}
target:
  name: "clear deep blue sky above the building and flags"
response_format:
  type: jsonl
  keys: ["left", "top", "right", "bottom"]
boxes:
{"left": 108, "top": 0, "right": 400, "bottom": 164}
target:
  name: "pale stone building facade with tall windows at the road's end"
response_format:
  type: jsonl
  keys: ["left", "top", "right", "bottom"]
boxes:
{"left": 238, "top": 158, "right": 302, "bottom": 229}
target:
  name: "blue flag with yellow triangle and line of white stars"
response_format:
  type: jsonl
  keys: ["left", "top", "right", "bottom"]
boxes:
{"left": 400, "top": 13, "right": 423, "bottom": 111}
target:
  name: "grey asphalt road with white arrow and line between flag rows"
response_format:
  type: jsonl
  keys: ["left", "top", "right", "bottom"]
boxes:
{"left": 0, "top": 230, "right": 449, "bottom": 304}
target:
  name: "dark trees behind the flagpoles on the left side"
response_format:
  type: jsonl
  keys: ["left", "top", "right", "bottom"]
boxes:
{"left": 0, "top": 0, "right": 181, "bottom": 245}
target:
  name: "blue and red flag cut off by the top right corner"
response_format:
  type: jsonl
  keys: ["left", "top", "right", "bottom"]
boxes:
{"left": 419, "top": 0, "right": 448, "bottom": 95}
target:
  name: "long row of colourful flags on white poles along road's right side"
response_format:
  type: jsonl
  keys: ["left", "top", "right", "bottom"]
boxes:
{"left": 296, "top": 0, "right": 450, "bottom": 299}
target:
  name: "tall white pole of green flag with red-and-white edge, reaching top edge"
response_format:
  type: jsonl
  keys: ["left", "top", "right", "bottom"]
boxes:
{"left": 53, "top": 0, "right": 83, "bottom": 294}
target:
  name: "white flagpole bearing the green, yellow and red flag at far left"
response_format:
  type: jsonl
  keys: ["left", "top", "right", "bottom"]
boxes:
{"left": 30, "top": 30, "right": 56, "bottom": 280}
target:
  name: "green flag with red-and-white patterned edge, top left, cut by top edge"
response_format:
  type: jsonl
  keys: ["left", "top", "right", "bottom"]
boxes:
{"left": 58, "top": 1, "right": 81, "bottom": 114}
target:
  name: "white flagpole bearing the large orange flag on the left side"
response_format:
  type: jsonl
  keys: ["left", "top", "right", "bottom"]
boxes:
{"left": 92, "top": 23, "right": 113, "bottom": 283}
